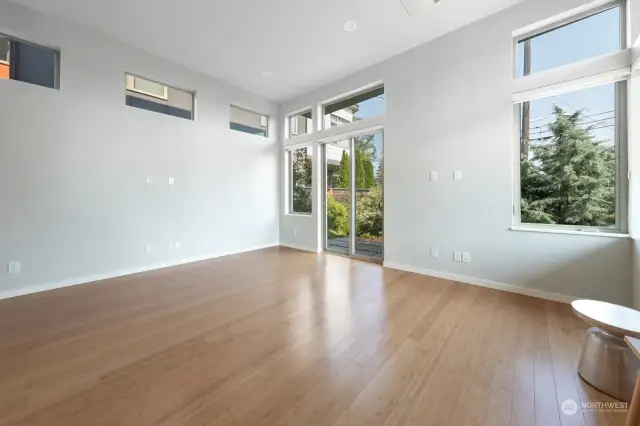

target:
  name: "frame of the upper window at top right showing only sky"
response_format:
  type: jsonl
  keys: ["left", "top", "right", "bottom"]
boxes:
{"left": 513, "top": 0, "right": 629, "bottom": 79}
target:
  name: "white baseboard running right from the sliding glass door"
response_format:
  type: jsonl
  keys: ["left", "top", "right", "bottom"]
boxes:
{"left": 384, "top": 262, "right": 580, "bottom": 303}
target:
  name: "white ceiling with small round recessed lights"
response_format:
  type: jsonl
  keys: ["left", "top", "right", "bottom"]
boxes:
{"left": 7, "top": 0, "right": 523, "bottom": 101}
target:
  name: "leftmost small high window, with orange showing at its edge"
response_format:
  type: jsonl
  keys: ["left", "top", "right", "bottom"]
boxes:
{"left": 0, "top": 34, "right": 60, "bottom": 89}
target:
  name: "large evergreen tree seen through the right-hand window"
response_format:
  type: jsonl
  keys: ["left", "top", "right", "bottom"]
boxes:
{"left": 521, "top": 106, "right": 616, "bottom": 226}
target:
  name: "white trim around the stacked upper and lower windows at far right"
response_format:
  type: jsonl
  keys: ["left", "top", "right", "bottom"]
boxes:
{"left": 510, "top": 0, "right": 632, "bottom": 238}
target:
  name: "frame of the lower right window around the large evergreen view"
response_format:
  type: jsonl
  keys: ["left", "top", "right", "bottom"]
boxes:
{"left": 511, "top": 77, "right": 629, "bottom": 236}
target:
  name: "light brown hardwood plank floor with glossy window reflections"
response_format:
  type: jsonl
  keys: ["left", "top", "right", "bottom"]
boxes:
{"left": 0, "top": 248, "right": 625, "bottom": 426}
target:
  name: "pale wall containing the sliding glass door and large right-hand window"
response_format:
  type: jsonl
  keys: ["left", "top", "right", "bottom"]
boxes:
{"left": 280, "top": 0, "right": 632, "bottom": 305}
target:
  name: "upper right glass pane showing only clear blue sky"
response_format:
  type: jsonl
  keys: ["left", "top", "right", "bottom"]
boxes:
{"left": 518, "top": 6, "right": 622, "bottom": 77}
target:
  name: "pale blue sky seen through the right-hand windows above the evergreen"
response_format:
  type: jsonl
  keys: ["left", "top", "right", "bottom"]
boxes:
{"left": 517, "top": 7, "right": 622, "bottom": 143}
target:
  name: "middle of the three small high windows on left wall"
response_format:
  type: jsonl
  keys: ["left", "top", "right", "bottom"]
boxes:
{"left": 125, "top": 74, "right": 194, "bottom": 120}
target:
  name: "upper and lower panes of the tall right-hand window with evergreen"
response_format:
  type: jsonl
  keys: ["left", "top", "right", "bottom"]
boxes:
{"left": 514, "top": 5, "right": 628, "bottom": 232}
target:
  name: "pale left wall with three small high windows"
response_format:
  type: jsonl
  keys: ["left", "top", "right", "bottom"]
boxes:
{"left": 0, "top": 2, "right": 279, "bottom": 297}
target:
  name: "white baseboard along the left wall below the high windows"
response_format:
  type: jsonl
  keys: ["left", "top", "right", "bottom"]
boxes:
{"left": 0, "top": 243, "right": 279, "bottom": 300}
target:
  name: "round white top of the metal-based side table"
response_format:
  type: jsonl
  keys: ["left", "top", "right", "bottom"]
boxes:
{"left": 571, "top": 300, "right": 640, "bottom": 339}
